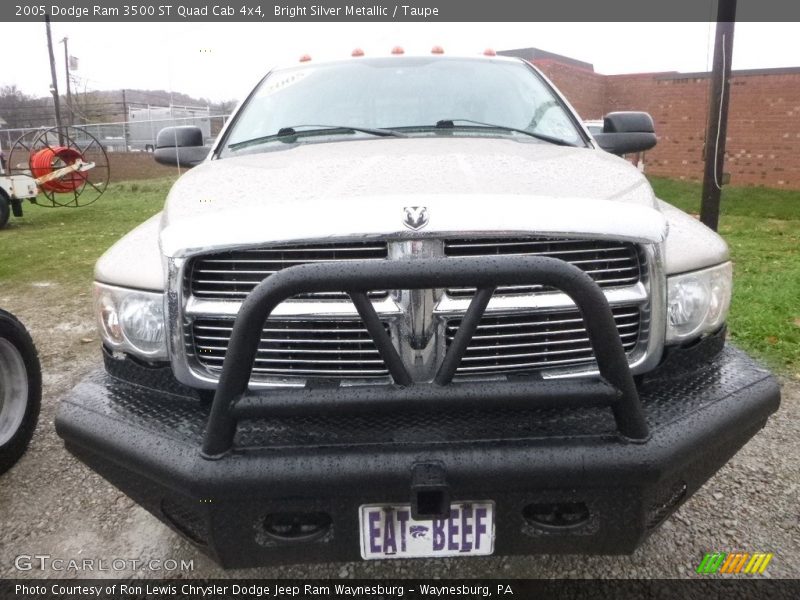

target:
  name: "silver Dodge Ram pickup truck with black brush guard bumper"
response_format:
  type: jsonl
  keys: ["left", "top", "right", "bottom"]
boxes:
{"left": 57, "top": 49, "right": 780, "bottom": 567}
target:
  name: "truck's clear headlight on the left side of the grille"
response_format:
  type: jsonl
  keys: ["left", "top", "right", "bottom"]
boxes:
{"left": 94, "top": 283, "right": 167, "bottom": 360}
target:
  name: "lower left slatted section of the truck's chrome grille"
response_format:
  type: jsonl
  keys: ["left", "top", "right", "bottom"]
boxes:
{"left": 194, "top": 318, "right": 389, "bottom": 378}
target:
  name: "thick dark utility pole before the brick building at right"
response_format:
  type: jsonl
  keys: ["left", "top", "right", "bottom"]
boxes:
{"left": 700, "top": 0, "right": 736, "bottom": 231}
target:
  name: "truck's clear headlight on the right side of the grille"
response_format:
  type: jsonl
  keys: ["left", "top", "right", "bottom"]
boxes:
{"left": 667, "top": 262, "right": 732, "bottom": 343}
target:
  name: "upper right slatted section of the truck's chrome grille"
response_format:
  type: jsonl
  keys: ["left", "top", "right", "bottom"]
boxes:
{"left": 444, "top": 237, "right": 645, "bottom": 297}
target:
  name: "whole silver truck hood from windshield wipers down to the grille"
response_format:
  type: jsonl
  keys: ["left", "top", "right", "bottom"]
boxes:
{"left": 161, "top": 137, "right": 666, "bottom": 256}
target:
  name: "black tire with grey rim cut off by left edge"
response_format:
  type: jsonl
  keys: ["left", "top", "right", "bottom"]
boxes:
{"left": 0, "top": 310, "right": 42, "bottom": 473}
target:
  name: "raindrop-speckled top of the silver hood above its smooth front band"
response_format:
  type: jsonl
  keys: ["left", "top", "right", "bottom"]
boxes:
{"left": 161, "top": 137, "right": 655, "bottom": 223}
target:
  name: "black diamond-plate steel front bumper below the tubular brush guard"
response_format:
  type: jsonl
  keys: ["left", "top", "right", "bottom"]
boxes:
{"left": 56, "top": 340, "right": 780, "bottom": 567}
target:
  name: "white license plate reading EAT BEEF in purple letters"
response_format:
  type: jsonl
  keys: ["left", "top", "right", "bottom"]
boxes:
{"left": 359, "top": 501, "right": 494, "bottom": 560}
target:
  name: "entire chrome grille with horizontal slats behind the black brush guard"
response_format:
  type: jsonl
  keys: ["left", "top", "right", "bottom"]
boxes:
{"left": 176, "top": 235, "right": 652, "bottom": 384}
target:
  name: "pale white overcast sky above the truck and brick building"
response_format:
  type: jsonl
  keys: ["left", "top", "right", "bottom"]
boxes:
{"left": 0, "top": 22, "right": 800, "bottom": 101}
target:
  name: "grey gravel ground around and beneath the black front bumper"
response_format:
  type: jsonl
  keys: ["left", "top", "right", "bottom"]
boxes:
{"left": 0, "top": 282, "right": 800, "bottom": 578}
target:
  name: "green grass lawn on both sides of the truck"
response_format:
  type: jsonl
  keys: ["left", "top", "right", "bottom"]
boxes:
{"left": 0, "top": 173, "right": 800, "bottom": 378}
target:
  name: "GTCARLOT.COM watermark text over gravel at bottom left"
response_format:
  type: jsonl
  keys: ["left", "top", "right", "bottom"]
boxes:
{"left": 14, "top": 554, "right": 194, "bottom": 573}
